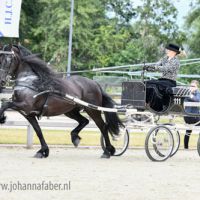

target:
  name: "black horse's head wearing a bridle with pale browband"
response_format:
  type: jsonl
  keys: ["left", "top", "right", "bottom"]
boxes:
{"left": 0, "top": 45, "right": 20, "bottom": 86}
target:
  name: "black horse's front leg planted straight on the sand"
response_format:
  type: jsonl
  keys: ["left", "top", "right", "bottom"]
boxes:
{"left": 25, "top": 115, "right": 49, "bottom": 158}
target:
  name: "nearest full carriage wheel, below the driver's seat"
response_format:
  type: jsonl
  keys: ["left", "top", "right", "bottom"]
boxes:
{"left": 145, "top": 125, "right": 174, "bottom": 161}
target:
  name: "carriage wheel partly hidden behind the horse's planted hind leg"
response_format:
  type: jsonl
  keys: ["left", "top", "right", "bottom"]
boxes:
{"left": 101, "top": 128, "right": 129, "bottom": 156}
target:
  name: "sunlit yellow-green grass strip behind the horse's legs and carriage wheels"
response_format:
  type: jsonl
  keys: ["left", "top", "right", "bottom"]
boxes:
{"left": 0, "top": 128, "right": 198, "bottom": 148}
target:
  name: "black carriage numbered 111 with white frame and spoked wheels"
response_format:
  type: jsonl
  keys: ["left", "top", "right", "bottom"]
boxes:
{"left": 99, "top": 76, "right": 200, "bottom": 161}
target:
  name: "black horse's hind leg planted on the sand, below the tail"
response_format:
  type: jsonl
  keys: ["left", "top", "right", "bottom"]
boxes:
{"left": 86, "top": 109, "right": 115, "bottom": 158}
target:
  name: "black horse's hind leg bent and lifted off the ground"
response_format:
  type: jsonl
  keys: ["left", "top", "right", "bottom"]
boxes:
{"left": 65, "top": 109, "right": 89, "bottom": 147}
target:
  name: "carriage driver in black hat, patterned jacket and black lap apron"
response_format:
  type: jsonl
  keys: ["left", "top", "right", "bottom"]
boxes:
{"left": 144, "top": 44, "right": 180, "bottom": 112}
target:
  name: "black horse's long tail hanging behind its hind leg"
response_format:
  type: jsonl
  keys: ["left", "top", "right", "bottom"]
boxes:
{"left": 102, "top": 90, "right": 124, "bottom": 135}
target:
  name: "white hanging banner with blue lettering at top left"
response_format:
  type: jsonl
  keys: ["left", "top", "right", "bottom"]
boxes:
{"left": 0, "top": 0, "right": 22, "bottom": 37}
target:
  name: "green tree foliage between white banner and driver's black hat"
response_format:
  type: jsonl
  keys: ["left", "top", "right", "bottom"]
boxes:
{"left": 0, "top": 0, "right": 187, "bottom": 72}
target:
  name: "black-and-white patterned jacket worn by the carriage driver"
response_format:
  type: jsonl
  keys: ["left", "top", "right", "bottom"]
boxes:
{"left": 155, "top": 56, "right": 180, "bottom": 81}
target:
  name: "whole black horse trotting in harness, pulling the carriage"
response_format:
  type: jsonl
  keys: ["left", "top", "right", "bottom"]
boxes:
{"left": 0, "top": 46, "right": 123, "bottom": 158}
